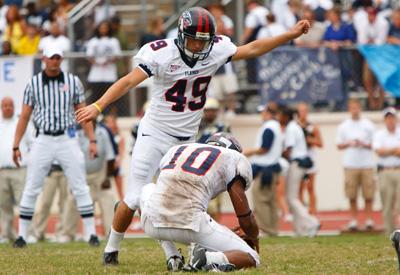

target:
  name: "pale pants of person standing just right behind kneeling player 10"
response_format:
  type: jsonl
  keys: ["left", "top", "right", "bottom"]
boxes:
{"left": 286, "top": 161, "right": 318, "bottom": 236}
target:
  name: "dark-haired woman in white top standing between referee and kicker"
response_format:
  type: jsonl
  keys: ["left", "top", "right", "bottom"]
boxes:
{"left": 86, "top": 21, "right": 121, "bottom": 113}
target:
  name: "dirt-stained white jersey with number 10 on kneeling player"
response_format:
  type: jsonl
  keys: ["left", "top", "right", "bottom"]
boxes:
{"left": 144, "top": 143, "right": 252, "bottom": 232}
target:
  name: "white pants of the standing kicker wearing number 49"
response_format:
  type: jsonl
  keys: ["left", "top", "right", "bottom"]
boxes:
{"left": 124, "top": 119, "right": 194, "bottom": 210}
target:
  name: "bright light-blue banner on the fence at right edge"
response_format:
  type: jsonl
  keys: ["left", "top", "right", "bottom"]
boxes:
{"left": 358, "top": 45, "right": 400, "bottom": 97}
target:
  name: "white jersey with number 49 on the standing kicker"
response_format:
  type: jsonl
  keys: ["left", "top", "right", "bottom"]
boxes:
{"left": 134, "top": 36, "right": 237, "bottom": 137}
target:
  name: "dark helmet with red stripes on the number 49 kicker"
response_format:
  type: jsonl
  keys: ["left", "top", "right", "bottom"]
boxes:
{"left": 177, "top": 7, "right": 216, "bottom": 60}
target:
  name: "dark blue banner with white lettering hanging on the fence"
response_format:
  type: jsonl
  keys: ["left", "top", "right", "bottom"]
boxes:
{"left": 258, "top": 47, "right": 343, "bottom": 104}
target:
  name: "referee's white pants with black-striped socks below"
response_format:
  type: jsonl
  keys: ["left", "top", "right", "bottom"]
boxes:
{"left": 20, "top": 134, "right": 93, "bottom": 226}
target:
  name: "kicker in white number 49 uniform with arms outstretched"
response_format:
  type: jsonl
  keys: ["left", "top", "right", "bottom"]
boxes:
{"left": 76, "top": 7, "right": 310, "bottom": 272}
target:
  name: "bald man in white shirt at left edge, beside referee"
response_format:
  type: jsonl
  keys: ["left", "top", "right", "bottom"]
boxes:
{"left": 0, "top": 97, "right": 28, "bottom": 242}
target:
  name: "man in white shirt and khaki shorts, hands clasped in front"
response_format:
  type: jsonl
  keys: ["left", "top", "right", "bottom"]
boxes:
{"left": 336, "top": 99, "right": 375, "bottom": 230}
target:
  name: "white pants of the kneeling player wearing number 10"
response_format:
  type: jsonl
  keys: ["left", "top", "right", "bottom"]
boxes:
{"left": 141, "top": 183, "right": 260, "bottom": 266}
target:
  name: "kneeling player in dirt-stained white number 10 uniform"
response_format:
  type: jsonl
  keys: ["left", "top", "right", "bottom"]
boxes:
{"left": 140, "top": 133, "right": 260, "bottom": 271}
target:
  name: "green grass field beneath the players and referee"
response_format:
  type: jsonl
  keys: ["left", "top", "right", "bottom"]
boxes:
{"left": 0, "top": 234, "right": 397, "bottom": 274}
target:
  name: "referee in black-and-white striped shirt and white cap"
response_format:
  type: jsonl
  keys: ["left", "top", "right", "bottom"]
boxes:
{"left": 13, "top": 46, "right": 99, "bottom": 247}
